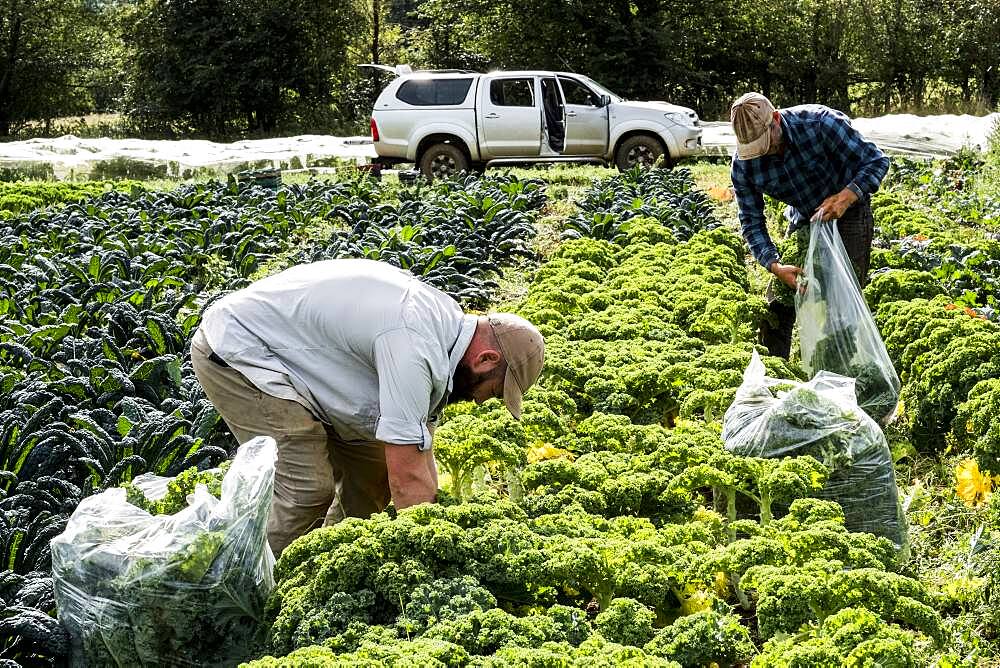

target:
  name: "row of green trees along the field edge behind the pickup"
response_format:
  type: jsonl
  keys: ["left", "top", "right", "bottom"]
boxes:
{"left": 0, "top": 0, "right": 1000, "bottom": 137}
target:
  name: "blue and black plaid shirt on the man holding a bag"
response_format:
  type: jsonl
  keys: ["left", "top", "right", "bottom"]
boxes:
{"left": 732, "top": 104, "right": 889, "bottom": 268}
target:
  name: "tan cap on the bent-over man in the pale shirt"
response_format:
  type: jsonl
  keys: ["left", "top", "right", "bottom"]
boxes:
{"left": 487, "top": 313, "right": 545, "bottom": 420}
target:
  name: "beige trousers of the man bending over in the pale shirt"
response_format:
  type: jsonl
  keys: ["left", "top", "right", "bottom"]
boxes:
{"left": 191, "top": 330, "right": 390, "bottom": 556}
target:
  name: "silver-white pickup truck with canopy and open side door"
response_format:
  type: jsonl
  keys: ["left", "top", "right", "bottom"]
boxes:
{"left": 371, "top": 68, "right": 701, "bottom": 178}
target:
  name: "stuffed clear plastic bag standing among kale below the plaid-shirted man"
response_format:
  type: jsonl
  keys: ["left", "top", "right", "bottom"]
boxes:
{"left": 722, "top": 351, "right": 909, "bottom": 560}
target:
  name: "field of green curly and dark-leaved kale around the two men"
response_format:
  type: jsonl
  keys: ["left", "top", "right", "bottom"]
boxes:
{"left": 0, "top": 155, "right": 1000, "bottom": 668}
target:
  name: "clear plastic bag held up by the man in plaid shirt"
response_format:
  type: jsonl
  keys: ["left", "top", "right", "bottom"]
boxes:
{"left": 795, "top": 220, "right": 900, "bottom": 424}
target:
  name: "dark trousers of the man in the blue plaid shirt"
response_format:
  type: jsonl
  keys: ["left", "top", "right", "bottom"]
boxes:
{"left": 760, "top": 198, "right": 875, "bottom": 359}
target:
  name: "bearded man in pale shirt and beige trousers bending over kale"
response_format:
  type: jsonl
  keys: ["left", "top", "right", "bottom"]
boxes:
{"left": 191, "top": 260, "right": 544, "bottom": 555}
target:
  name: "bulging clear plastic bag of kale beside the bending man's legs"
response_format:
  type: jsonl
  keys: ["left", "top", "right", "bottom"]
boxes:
{"left": 51, "top": 437, "right": 277, "bottom": 668}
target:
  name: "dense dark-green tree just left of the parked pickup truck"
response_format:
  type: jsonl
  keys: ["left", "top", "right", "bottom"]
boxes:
{"left": 128, "top": 0, "right": 367, "bottom": 136}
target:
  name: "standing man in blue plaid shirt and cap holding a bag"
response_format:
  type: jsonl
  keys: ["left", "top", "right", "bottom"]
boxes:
{"left": 730, "top": 93, "right": 889, "bottom": 359}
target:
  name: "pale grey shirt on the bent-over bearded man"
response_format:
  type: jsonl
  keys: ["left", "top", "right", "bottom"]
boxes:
{"left": 201, "top": 259, "right": 476, "bottom": 449}
